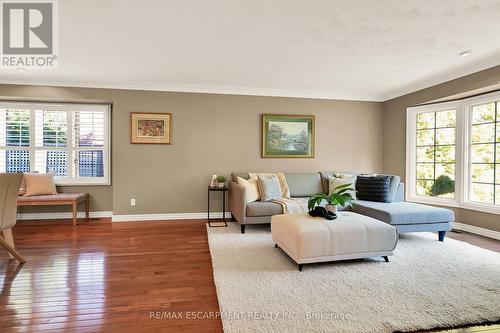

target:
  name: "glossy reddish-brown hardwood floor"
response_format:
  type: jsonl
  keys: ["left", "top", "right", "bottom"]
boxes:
{"left": 0, "top": 219, "right": 500, "bottom": 333}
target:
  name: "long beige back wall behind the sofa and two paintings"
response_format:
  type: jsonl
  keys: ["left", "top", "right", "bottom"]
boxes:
{"left": 0, "top": 85, "right": 383, "bottom": 214}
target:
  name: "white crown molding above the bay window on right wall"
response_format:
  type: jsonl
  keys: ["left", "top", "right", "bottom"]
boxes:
{"left": 380, "top": 54, "right": 500, "bottom": 101}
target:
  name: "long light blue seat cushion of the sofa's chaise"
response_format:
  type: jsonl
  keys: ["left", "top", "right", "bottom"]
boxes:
{"left": 352, "top": 200, "right": 455, "bottom": 225}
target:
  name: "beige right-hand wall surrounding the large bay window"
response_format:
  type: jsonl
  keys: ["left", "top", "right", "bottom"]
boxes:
{"left": 383, "top": 66, "right": 500, "bottom": 231}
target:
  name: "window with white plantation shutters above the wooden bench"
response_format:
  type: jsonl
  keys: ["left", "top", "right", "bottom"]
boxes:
{"left": 0, "top": 102, "right": 110, "bottom": 185}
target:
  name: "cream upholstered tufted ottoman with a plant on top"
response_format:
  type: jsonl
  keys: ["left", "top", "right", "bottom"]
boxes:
{"left": 271, "top": 212, "right": 397, "bottom": 271}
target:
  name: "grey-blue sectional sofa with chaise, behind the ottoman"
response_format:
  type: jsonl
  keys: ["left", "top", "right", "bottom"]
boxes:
{"left": 229, "top": 172, "right": 455, "bottom": 241}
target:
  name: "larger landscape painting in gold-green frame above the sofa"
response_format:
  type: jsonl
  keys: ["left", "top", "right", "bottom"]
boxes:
{"left": 262, "top": 114, "right": 315, "bottom": 158}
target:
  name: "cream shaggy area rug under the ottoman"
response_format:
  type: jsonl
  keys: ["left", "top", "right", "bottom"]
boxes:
{"left": 208, "top": 223, "right": 500, "bottom": 333}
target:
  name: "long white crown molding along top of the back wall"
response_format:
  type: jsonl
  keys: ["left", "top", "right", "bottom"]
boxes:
{"left": 0, "top": 79, "right": 384, "bottom": 102}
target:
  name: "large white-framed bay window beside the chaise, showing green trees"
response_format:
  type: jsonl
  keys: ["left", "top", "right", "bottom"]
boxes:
{"left": 406, "top": 92, "right": 500, "bottom": 214}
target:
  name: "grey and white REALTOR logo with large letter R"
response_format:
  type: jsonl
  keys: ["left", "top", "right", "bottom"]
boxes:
{"left": 1, "top": 0, "right": 57, "bottom": 68}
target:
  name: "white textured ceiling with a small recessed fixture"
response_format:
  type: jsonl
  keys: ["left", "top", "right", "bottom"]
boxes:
{"left": 0, "top": 0, "right": 500, "bottom": 101}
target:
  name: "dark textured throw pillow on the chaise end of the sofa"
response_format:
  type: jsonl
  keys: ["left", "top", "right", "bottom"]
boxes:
{"left": 356, "top": 175, "right": 391, "bottom": 202}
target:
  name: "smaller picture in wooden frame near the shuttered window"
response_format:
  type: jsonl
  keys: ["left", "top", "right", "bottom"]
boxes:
{"left": 130, "top": 112, "right": 172, "bottom": 145}
